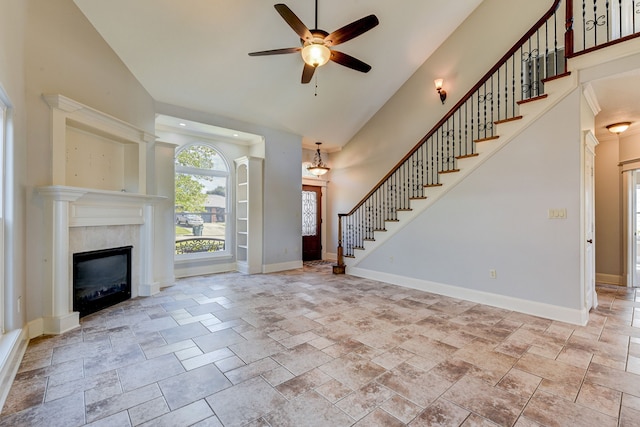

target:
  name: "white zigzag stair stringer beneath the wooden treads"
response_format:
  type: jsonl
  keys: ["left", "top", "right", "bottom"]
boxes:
{"left": 344, "top": 73, "right": 579, "bottom": 275}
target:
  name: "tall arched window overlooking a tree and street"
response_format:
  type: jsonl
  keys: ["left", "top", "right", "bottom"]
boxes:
{"left": 175, "top": 143, "right": 231, "bottom": 257}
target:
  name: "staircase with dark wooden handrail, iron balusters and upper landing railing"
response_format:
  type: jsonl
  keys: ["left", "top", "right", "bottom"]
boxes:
{"left": 334, "top": 0, "right": 640, "bottom": 274}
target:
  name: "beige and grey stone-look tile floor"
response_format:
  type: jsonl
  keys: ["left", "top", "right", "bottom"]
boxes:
{"left": 0, "top": 265, "right": 640, "bottom": 427}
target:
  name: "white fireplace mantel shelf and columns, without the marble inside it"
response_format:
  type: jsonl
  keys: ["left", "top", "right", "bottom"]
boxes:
{"left": 36, "top": 185, "right": 166, "bottom": 334}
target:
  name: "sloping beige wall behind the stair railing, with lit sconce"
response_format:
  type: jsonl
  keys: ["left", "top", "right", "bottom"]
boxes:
{"left": 328, "top": 0, "right": 552, "bottom": 252}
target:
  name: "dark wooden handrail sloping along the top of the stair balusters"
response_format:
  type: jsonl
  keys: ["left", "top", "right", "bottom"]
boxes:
{"left": 338, "top": 0, "right": 560, "bottom": 222}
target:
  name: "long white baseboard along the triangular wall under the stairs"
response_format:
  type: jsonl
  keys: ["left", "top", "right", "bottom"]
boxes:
{"left": 347, "top": 267, "right": 589, "bottom": 326}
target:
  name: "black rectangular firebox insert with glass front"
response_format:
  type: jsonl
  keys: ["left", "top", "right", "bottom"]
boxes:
{"left": 73, "top": 246, "right": 132, "bottom": 317}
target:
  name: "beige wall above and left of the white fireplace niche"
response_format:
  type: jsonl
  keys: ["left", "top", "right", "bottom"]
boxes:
{"left": 21, "top": 0, "right": 155, "bottom": 328}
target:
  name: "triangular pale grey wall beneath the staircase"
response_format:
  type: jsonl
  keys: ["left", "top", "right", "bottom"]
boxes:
{"left": 358, "top": 90, "right": 582, "bottom": 310}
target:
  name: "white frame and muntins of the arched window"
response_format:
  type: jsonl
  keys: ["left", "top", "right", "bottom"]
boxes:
{"left": 173, "top": 141, "right": 235, "bottom": 262}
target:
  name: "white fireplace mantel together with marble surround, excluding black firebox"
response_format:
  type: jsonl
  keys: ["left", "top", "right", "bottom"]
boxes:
{"left": 37, "top": 185, "right": 164, "bottom": 334}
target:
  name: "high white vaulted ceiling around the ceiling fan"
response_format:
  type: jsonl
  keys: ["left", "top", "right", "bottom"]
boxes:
{"left": 74, "top": 0, "right": 482, "bottom": 149}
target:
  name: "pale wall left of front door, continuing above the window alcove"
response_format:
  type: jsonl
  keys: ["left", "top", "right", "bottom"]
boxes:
{"left": 156, "top": 103, "right": 302, "bottom": 272}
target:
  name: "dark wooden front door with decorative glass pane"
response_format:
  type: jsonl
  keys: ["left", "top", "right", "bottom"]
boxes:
{"left": 302, "top": 185, "right": 322, "bottom": 261}
